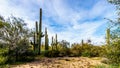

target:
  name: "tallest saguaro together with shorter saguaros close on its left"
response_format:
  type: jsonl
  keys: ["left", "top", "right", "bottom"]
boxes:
{"left": 31, "top": 9, "right": 44, "bottom": 55}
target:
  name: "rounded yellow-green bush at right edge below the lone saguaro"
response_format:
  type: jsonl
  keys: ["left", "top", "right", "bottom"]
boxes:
{"left": 106, "top": 40, "right": 120, "bottom": 64}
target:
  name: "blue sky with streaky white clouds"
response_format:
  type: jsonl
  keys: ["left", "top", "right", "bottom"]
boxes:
{"left": 0, "top": 0, "right": 116, "bottom": 45}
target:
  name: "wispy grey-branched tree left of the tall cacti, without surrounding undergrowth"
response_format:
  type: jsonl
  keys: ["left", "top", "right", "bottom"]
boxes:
{"left": 0, "top": 16, "right": 30, "bottom": 61}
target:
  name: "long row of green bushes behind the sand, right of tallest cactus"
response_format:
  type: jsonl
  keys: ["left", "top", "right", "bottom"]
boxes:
{"left": 45, "top": 40, "right": 106, "bottom": 57}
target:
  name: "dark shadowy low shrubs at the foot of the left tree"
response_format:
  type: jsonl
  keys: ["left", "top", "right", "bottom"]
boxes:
{"left": 7, "top": 50, "right": 35, "bottom": 63}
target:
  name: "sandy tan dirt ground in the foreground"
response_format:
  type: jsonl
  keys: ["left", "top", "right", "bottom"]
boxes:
{"left": 13, "top": 57, "right": 105, "bottom": 68}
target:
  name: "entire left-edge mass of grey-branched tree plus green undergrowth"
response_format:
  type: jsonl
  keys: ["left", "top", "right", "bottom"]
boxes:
{"left": 0, "top": 16, "right": 34, "bottom": 64}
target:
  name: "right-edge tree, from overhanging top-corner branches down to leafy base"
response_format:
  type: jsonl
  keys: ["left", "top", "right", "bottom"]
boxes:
{"left": 107, "top": 0, "right": 120, "bottom": 64}
